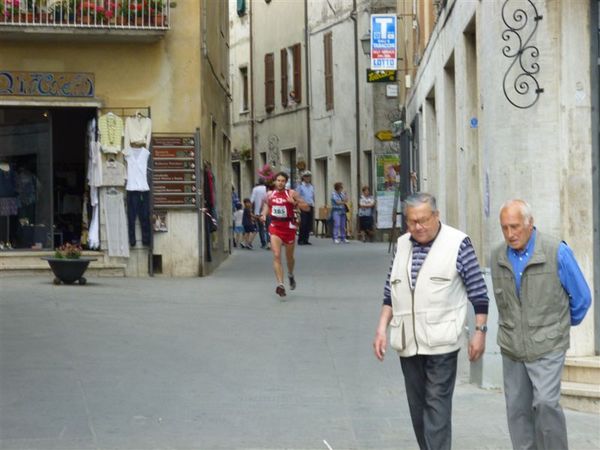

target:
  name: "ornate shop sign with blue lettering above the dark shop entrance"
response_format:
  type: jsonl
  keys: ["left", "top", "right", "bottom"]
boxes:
{"left": 0, "top": 71, "right": 95, "bottom": 97}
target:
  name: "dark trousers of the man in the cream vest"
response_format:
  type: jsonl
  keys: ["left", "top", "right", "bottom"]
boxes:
{"left": 400, "top": 350, "right": 458, "bottom": 450}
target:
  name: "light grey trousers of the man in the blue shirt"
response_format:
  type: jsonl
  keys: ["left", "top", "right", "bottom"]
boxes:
{"left": 502, "top": 351, "right": 569, "bottom": 450}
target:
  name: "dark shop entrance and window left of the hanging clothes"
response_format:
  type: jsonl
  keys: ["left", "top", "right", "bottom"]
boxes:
{"left": 0, "top": 107, "right": 96, "bottom": 251}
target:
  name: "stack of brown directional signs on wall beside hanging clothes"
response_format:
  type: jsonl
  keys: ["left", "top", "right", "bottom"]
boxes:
{"left": 152, "top": 136, "right": 198, "bottom": 208}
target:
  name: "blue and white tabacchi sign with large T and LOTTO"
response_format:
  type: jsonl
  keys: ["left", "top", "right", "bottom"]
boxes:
{"left": 371, "top": 14, "right": 396, "bottom": 70}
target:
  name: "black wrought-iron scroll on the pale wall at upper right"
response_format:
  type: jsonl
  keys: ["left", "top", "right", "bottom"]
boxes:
{"left": 502, "top": 0, "right": 544, "bottom": 109}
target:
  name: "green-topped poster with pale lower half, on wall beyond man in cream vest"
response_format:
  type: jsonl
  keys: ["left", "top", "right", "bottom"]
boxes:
{"left": 376, "top": 155, "right": 400, "bottom": 229}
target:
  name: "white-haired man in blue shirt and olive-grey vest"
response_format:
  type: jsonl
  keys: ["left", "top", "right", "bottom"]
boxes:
{"left": 492, "top": 199, "right": 591, "bottom": 450}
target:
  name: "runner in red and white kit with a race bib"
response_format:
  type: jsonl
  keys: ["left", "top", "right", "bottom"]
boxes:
{"left": 260, "top": 172, "right": 310, "bottom": 297}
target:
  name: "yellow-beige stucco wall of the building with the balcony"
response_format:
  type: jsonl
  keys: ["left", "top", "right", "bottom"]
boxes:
{"left": 0, "top": 1, "right": 230, "bottom": 276}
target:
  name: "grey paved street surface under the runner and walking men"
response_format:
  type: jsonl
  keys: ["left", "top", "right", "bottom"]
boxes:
{"left": 0, "top": 238, "right": 600, "bottom": 450}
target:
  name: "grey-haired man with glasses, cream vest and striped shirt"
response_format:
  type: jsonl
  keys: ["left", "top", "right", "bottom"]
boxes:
{"left": 373, "top": 193, "right": 488, "bottom": 450}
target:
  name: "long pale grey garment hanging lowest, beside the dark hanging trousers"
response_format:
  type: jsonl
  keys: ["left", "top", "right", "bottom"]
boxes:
{"left": 101, "top": 188, "right": 129, "bottom": 258}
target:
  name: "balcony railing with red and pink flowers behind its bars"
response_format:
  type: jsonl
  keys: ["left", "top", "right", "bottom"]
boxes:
{"left": 0, "top": 0, "right": 170, "bottom": 29}
